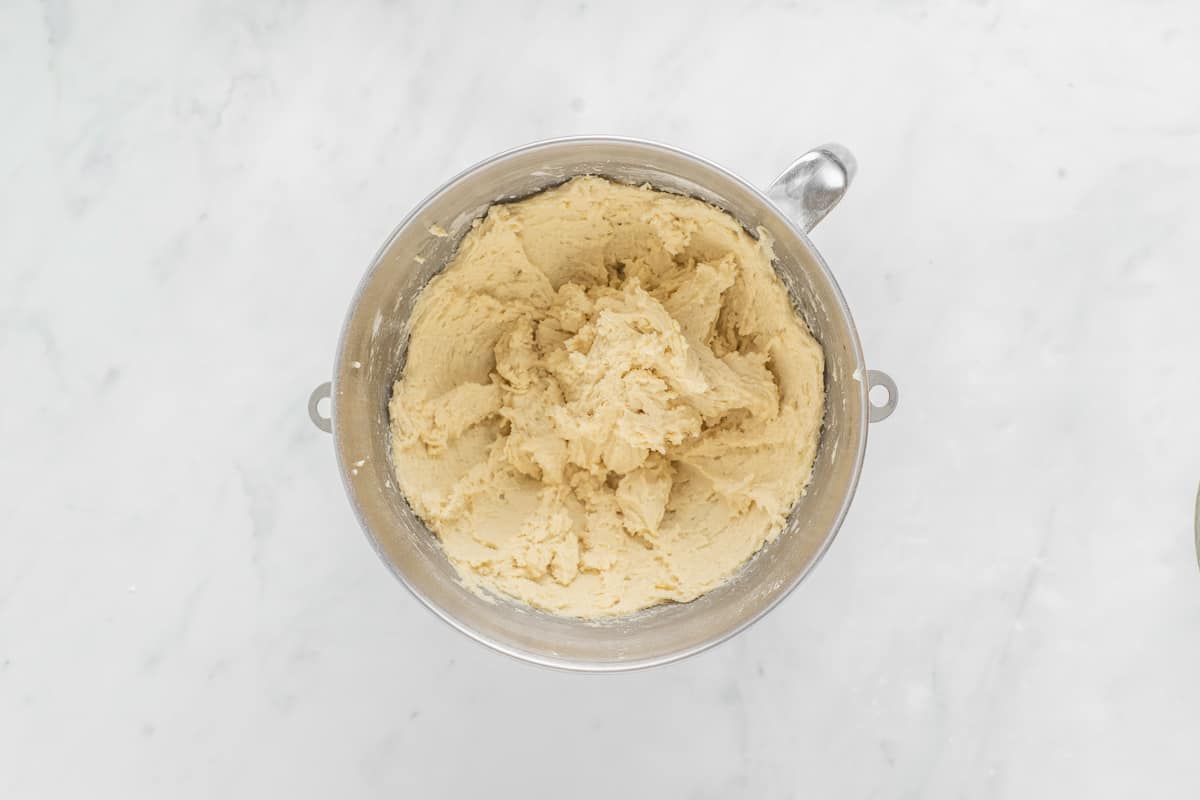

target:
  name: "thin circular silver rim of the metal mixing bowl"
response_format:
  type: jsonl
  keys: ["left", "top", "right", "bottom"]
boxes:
{"left": 330, "top": 134, "right": 870, "bottom": 673}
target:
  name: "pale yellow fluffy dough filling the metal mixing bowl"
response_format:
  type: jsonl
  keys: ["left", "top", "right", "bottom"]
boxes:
{"left": 390, "top": 178, "right": 823, "bottom": 618}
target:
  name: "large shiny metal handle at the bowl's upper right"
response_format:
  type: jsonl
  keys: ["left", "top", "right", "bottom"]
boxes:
{"left": 767, "top": 143, "right": 858, "bottom": 233}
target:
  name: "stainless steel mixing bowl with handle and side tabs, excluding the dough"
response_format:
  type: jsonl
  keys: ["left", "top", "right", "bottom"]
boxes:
{"left": 308, "top": 137, "right": 898, "bottom": 672}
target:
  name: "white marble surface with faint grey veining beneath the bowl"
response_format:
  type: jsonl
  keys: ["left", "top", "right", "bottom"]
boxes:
{"left": 0, "top": 0, "right": 1200, "bottom": 799}
